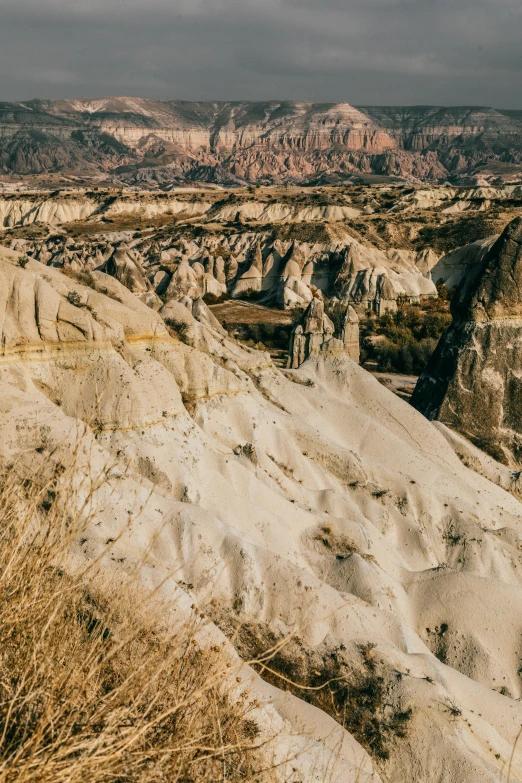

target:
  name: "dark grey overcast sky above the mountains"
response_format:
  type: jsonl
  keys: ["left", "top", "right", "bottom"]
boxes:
{"left": 0, "top": 0, "right": 522, "bottom": 109}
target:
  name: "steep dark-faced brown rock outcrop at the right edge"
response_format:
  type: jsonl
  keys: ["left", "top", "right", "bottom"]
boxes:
{"left": 412, "top": 218, "right": 522, "bottom": 467}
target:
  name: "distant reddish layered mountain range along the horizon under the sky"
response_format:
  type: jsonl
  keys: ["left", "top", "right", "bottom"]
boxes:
{"left": 0, "top": 98, "right": 522, "bottom": 187}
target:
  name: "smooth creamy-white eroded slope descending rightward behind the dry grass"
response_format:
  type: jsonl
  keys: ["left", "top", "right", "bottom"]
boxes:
{"left": 0, "top": 249, "right": 522, "bottom": 783}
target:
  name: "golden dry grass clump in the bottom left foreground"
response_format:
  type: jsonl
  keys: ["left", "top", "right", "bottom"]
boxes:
{"left": 0, "top": 460, "right": 266, "bottom": 783}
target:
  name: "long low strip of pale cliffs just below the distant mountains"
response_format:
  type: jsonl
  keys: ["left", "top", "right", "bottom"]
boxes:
{"left": 0, "top": 187, "right": 522, "bottom": 229}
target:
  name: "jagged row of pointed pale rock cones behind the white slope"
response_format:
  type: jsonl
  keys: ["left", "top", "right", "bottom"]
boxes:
{"left": 8, "top": 214, "right": 437, "bottom": 314}
